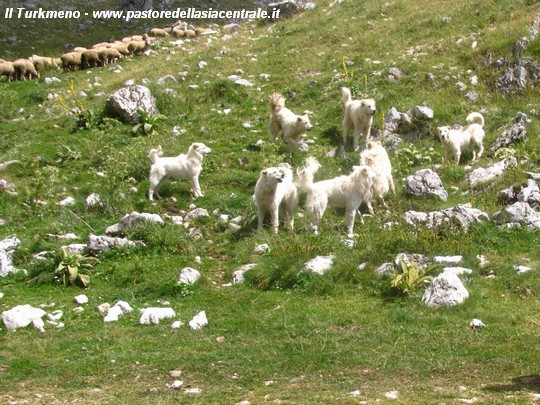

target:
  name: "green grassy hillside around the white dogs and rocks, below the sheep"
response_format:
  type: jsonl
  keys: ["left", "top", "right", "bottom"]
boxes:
{"left": 0, "top": 0, "right": 540, "bottom": 404}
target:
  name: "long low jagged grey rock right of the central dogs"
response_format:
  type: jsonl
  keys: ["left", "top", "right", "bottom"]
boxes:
{"left": 405, "top": 204, "right": 489, "bottom": 231}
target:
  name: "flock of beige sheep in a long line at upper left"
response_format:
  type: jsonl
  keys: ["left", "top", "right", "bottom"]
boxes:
{"left": 0, "top": 21, "right": 213, "bottom": 82}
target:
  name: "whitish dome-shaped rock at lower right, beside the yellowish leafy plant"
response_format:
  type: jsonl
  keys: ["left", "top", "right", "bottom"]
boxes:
{"left": 422, "top": 272, "right": 469, "bottom": 307}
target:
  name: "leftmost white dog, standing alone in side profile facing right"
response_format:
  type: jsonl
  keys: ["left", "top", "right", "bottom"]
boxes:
{"left": 148, "top": 142, "right": 212, "bottom": 200}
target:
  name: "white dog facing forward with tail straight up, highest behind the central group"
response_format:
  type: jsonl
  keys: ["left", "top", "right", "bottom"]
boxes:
{"left": 341, "top": 87, "right": 377, "bottom": 151}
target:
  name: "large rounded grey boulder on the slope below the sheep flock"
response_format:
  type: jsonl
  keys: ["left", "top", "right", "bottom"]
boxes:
{"left": 107, "top": 85, "right": 158, "bottom": 124}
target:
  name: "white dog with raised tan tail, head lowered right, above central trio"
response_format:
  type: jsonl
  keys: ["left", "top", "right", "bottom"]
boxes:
{"left": 269, "top": 93, "right": 313, "bottom": 151}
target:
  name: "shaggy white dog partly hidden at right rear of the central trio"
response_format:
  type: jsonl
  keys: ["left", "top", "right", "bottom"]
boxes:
{"left": 360, "top": 141, "right": 396, "bottom": 215}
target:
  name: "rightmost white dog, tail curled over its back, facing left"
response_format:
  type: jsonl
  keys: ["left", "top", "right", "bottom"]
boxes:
{"left": 438, "top": 112, "right": 485, "bottom": 165}
